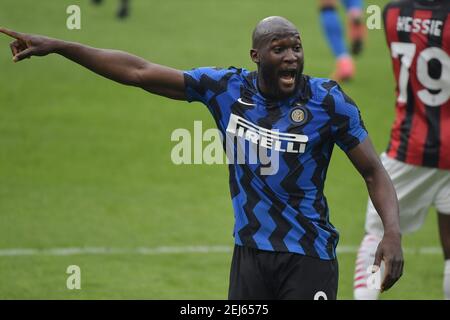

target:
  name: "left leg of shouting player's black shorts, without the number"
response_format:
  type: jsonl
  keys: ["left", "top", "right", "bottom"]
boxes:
{"left": 228, "top": 245, "right": 274, "bottom": 300}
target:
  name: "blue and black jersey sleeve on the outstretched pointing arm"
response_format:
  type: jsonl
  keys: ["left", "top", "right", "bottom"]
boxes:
{"left": 184, "top": 67, "right": 229, "bottom": 105}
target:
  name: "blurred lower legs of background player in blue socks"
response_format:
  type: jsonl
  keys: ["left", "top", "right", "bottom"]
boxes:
{"left": 319, "top": 0, "right": 366, "bottom": 81}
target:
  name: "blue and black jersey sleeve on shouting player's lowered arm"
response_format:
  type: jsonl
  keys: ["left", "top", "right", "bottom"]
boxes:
{"left": 331, "top": 85, "right": 368, "bottom": 152}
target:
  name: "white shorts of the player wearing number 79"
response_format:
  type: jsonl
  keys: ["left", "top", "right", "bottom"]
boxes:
{"left": 366, "top": 153, "right": 450, "bottom": 237}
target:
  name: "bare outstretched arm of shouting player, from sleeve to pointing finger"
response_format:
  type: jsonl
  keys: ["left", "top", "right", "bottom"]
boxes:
{"left": 0, "top": 28, "right": 186, "bottom": 100}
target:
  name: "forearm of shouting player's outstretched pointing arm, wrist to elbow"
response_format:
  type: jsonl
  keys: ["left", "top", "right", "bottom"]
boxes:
{"left": 53, "top": 40, "right": 148, "bottom": 86}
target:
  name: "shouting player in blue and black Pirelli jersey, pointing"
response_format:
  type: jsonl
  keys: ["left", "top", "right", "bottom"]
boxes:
{"left": 0, "top": 17, "right": 403, "bottom": 299}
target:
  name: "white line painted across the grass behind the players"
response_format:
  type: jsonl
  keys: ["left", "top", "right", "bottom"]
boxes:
{"left": 0, "top": 245, "right": 442, "bottom": 257}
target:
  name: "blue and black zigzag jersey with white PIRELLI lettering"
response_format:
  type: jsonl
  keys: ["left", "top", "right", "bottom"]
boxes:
{"left": 184, "top": 67, "right": 367, "bottom": 260}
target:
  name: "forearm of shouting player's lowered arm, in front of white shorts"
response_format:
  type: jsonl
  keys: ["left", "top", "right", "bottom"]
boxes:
{"left": 365, "top": 167, "right": 400, "bottom": 236}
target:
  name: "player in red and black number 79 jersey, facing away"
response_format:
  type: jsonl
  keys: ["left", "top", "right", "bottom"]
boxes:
{"left": 354, "top": 0, "right": 450, "bottom": 299}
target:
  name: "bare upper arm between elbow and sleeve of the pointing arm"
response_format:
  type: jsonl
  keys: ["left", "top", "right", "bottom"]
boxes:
{"left": 137, "top": 63, "right": 186, "bottom": 100}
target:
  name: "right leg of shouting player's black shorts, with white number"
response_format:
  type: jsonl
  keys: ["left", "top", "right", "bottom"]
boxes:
{"left": 276, "top": 255, "right": 339, "bottom": 300}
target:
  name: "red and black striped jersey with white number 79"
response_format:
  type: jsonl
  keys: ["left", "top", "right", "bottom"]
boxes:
{"left": 384, "top": 0, "right": 450, "bottom": 169}
